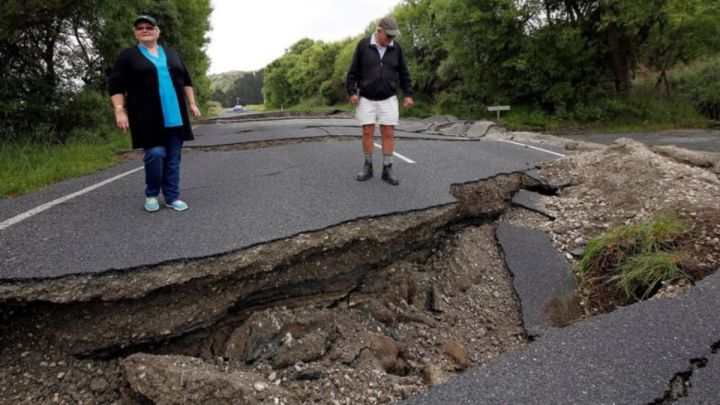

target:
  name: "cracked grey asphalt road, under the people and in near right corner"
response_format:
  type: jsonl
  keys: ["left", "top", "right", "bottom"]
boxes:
{"left": 0, "top": 115, "right": 720, "bottom": 404}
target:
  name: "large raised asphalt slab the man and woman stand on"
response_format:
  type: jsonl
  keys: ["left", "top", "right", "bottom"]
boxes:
{"left": 0, "top": 137, "right": 554, "bottom": 279}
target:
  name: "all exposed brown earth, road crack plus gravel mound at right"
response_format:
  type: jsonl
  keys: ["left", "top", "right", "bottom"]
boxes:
{"left": 0, "top": 134, "right": 720, "bottom": 404}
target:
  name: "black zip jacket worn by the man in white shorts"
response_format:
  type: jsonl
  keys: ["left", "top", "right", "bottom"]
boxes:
{"left": 345, "top": 34, "right": 412, "bottom": 100}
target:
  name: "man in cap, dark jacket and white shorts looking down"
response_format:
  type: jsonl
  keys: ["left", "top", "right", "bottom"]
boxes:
{"left": 346, "top": 16, "right": 413, "bottom": 186}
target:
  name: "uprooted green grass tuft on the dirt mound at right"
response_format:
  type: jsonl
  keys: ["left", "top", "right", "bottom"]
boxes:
{"left": 575, "top": 214, "right": 692, "bottom": 310}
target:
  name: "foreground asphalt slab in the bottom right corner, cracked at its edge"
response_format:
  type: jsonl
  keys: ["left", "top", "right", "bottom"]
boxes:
{"left": 404, "top": 273, "right": 720, "bottom": 405}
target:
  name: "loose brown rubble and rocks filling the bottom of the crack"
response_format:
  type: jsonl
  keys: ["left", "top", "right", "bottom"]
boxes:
{"left": 0, "top": 225, "right": 526, "bottom": 403}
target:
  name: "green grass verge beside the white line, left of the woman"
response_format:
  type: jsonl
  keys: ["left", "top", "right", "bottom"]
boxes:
{"left": 0, "top": 130, "right": 130, "bottom": 198}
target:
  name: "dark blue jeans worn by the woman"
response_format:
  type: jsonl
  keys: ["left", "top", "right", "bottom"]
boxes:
{"left": 143, "top": 127, "right": 183, "bottom": 204}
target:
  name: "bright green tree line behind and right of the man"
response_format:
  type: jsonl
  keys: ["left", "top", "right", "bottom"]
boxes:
{"left": 263, "top": 0, "right": 720, "bottom": 120}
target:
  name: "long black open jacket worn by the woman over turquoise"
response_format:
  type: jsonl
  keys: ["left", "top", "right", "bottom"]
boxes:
{"left": 110, "top": 46, "right": 194, "bottom": 148}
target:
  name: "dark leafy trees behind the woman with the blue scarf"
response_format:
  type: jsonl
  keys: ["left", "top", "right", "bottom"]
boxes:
{"left": 0, "top": 0, "right": 211, "bottom": 142}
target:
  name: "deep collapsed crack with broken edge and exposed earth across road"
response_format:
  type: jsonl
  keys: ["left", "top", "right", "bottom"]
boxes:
{"left": 0, "top": 174, "right": 556, "bottom": 403}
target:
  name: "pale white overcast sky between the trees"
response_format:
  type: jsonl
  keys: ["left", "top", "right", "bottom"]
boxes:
{"left": 207, "top": 0, "right": 401, "bottom": 73}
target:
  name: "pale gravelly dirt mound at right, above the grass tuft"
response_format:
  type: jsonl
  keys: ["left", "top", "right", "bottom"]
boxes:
{"left": 540, "top": 139, "right": 720, "bottom": 314}
